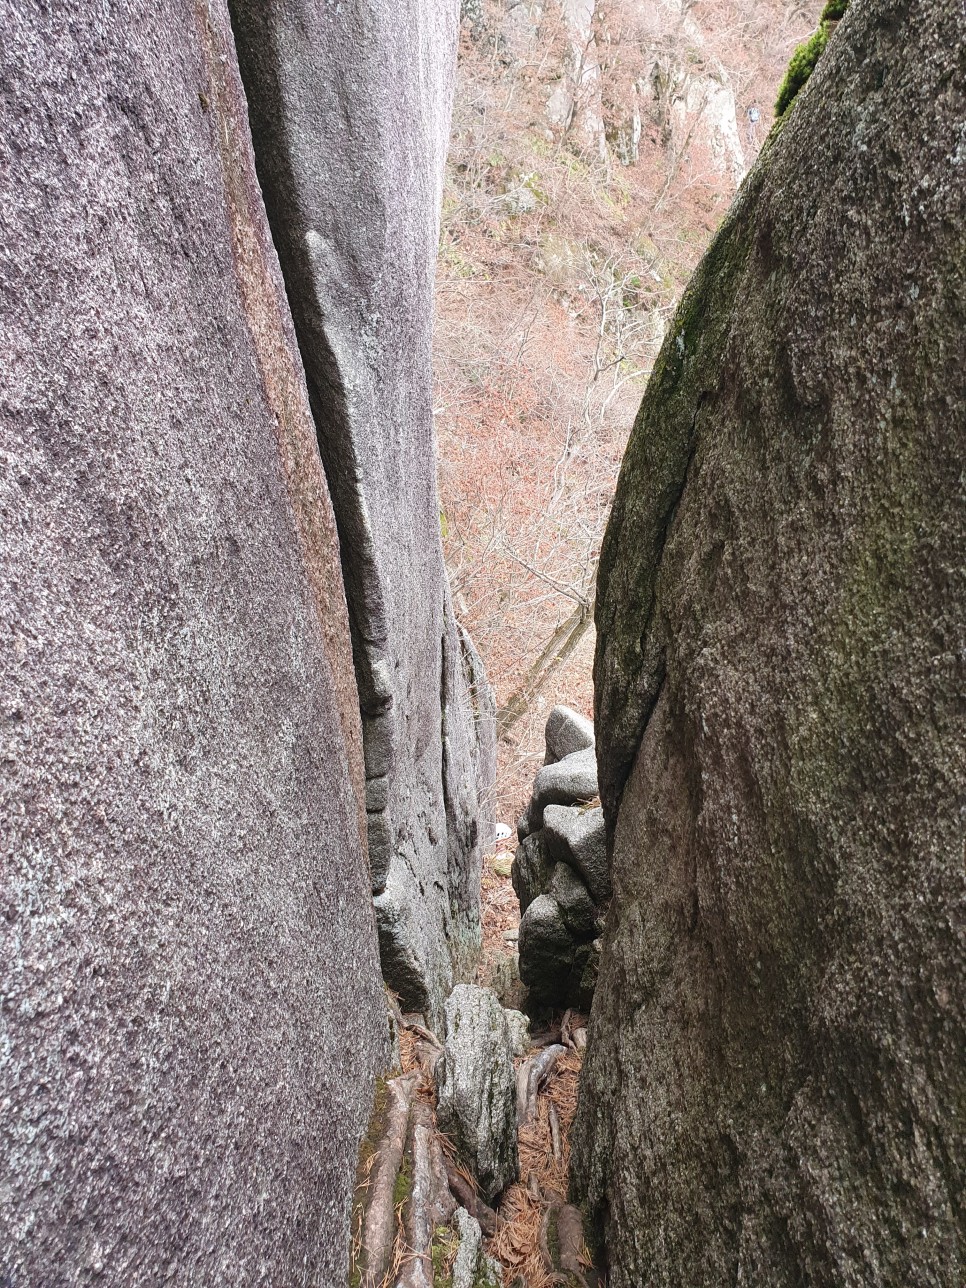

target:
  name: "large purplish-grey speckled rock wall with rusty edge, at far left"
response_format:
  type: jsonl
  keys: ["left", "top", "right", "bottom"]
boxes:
{"left": 0, "top": 0, "right": 391, "bottom": 1288}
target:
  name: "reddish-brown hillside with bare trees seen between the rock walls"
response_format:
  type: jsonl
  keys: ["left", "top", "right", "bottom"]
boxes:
{"left": 434, "top": 0, "right": 822, "bottom": 822}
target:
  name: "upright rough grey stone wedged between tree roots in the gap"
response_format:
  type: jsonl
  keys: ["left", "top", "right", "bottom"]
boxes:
{"left": 437, "top": 984, "right": 519, "bottom": 1203}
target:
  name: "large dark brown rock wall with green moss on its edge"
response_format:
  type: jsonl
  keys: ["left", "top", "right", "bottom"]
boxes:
{"left": 573, "top": 0, "right": 966, "bottom": 1288}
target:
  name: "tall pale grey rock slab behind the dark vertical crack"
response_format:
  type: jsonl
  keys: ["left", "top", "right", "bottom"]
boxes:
{"left": 231, "top": 0, "right": 496, "bottom": 1025}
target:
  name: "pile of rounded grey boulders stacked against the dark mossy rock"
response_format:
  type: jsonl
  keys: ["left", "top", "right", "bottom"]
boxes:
{"left": 510, "top": 706, "right": 611, "bottom": 1011}
